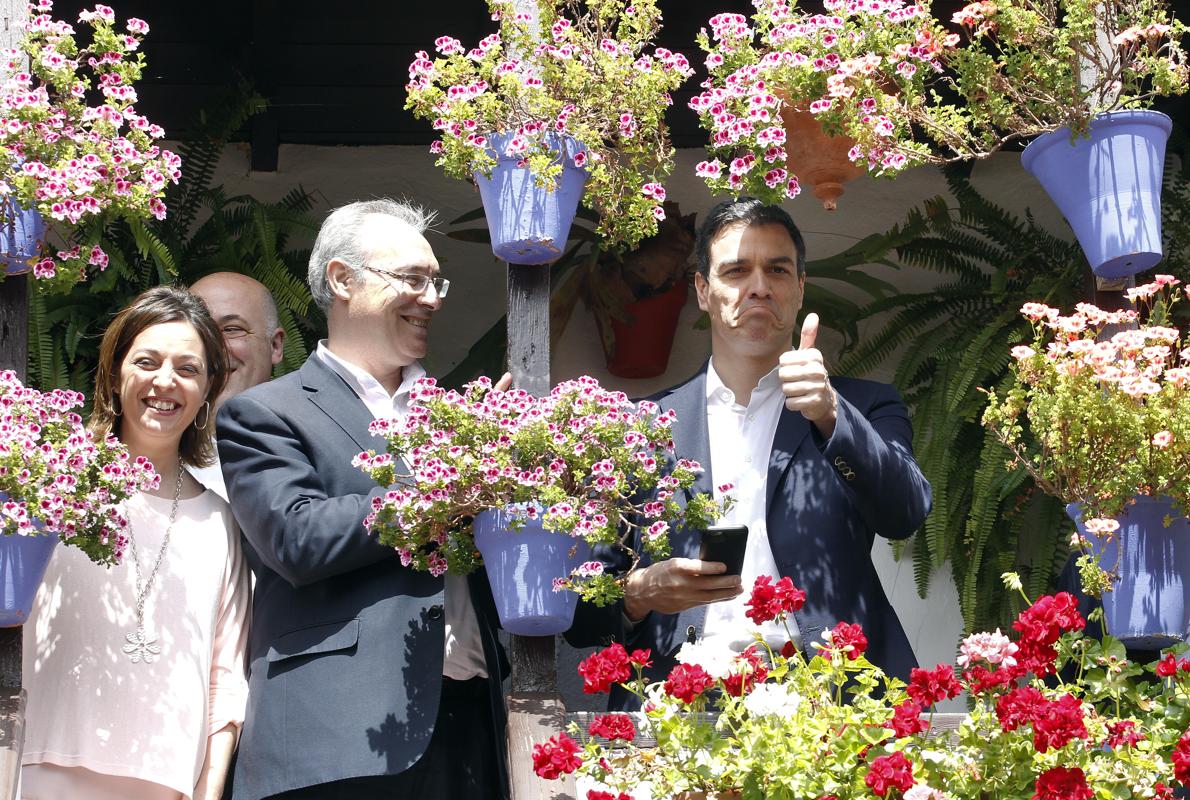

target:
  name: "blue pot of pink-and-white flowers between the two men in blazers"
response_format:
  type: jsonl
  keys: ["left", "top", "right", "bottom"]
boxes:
{"left": 355, "top": 377, "right": 725, "bottom": 636}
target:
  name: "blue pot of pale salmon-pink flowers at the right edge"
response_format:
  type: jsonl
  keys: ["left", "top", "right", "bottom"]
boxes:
{"left": 983, "top": 275, "right": 1190, "bottom": 646}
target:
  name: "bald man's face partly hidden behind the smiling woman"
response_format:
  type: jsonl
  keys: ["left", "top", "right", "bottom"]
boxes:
{"left": 190, "top": 273, "right": 286, "bottom": 411}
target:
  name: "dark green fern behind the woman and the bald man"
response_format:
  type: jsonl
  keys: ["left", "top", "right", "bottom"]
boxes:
{"left": 29, "top": 86, "right": 321, "bottom": 392}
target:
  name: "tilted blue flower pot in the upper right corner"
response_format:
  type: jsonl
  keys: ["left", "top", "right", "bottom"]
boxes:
{"left": 1021, "top": 111, "right": 1172, "bottom": 277}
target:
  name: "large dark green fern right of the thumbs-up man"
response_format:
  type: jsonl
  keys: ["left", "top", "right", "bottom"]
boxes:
{"left": 841, "top": 170, "right": 1086, "bottom": 630}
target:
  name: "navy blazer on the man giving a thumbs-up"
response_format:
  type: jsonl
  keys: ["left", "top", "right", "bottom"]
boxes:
{"left": 566, "top": 368, "right": 932, "bottom": 708}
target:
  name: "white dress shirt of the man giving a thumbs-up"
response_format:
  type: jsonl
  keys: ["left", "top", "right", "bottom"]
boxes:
{"left": 703, "top": 358, "right": 798, "bottom": 650}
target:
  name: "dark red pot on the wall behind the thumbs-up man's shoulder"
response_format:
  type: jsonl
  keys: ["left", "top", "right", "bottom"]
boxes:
{"left": 605, "top": 281, "right": 689, "bottom": 377}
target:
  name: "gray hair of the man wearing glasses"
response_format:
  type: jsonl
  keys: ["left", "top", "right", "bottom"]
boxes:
{"left": 306, "top": 198, "right": 437, "bottom": 313}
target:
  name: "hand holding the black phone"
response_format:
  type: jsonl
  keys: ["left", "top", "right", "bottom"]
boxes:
{"left": 624, "top": 558, "right": 744, "bottom": 621}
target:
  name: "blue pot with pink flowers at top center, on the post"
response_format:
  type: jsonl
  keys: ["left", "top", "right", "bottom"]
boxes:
{"left": 406, "top": 0, "right": 693, "bottom": 264}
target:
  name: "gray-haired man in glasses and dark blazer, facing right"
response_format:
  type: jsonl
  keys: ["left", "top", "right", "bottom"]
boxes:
{"left": 218, "top": 200, "right": 508, "bottom": 800}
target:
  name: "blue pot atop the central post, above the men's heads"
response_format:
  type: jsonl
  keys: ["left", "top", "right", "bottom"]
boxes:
{"left": 475, "top": 133, "right": 589, "bottom": 264}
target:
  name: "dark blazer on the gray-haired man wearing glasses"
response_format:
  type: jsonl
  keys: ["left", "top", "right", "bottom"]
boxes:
{"left": 217, "top": 355, "right": 507, "bottom": 800}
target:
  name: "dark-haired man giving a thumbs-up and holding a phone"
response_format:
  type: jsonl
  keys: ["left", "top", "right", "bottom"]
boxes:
{"left": 568, "top": 198, "right": 931, "bottom": 708}
